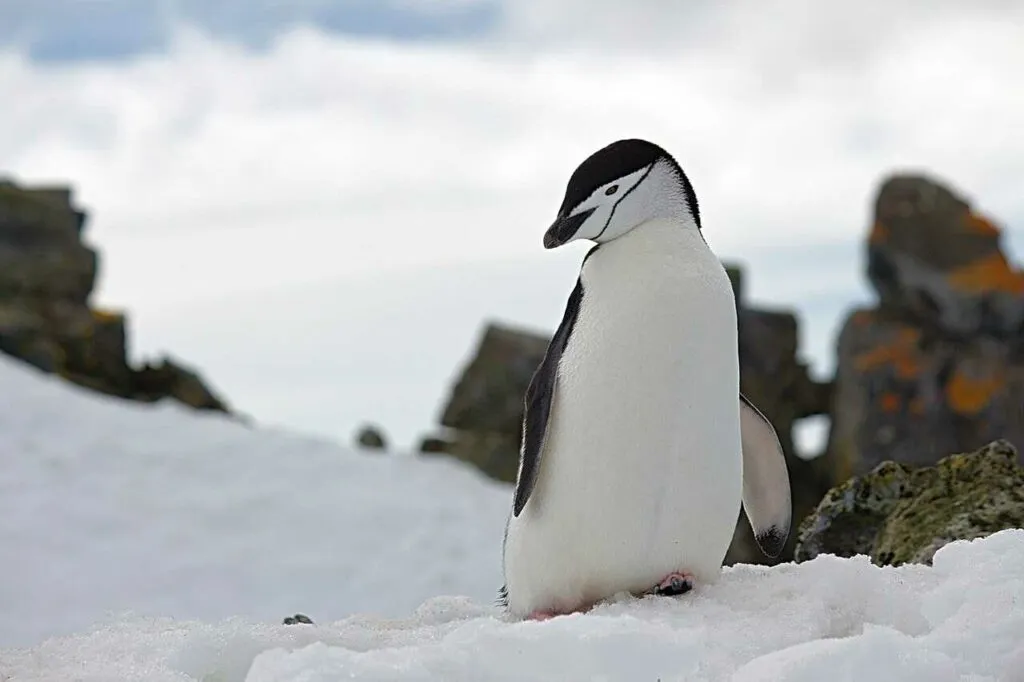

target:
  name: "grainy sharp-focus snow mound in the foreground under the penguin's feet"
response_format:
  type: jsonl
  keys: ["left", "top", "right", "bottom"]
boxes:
{"left": 0, "top": 530, "right": 1024, "bottom": 682}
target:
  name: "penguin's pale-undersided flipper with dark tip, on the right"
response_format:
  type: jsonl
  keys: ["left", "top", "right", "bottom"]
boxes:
{"left": 739, "top": 393, "right": 793, "bottom": 558}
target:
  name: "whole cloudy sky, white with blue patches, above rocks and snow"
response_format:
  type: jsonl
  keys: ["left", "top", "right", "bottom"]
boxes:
{"left": 0, "top": 0, "right": 1024, "bottom": 445}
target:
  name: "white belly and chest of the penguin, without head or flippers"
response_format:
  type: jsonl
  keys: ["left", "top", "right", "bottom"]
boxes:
{"left": 505, "top": 228, "right": 742, "bottom": 615}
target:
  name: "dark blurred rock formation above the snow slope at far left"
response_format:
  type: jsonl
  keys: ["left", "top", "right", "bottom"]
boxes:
{"left": 0, "top": 181, "right": 228, "bottom": 412}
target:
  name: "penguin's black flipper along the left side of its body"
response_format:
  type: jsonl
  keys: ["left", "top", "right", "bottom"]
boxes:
{"left": 512, "top": 274, "right": 589, "bottom": 516}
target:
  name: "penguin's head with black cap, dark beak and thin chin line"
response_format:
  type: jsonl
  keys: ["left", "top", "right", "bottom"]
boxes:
{"left": 544, "top": 139, "right": 700, "bottom": 249}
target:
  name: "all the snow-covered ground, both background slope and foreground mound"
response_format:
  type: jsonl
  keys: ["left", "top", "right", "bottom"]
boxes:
{"left": 0, "top": 350, "right": 1024, "bottom": 682}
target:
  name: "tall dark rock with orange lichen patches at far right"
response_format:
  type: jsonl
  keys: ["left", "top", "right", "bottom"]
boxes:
{"left": 827, "top": 175, "right": 1024, "bottom": 482}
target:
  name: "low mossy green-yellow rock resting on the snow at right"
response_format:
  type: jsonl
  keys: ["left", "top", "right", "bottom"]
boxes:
{"left": 795, "top": 439, "right": 1024, "bottom": 565}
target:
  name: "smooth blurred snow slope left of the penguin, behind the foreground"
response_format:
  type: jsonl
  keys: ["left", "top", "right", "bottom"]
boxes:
{"left": 0, "top": 354, "right": 511, "bottom": 647}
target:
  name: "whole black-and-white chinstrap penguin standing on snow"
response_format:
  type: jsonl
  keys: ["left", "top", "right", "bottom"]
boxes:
{"left": 499, "top": 138, "right": 792, "bottom": 620}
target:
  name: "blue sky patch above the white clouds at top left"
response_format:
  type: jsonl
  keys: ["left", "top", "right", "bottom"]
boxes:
{"left": 0, "top": 0, "right": 500, "bottom": 62}
